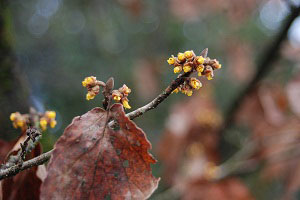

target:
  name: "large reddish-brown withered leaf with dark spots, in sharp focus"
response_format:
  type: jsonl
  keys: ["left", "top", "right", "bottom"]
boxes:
{"left": 41, "top": 104, "right": 159, "bottom": 200}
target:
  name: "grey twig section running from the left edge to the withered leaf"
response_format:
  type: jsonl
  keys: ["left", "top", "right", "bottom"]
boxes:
{"left": 0, "top": 150, "right": 53, "bottom": 180}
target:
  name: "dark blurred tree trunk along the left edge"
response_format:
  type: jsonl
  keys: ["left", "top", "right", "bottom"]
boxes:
{"left": 0, "top": 0, "right": 29, "bottom": 139}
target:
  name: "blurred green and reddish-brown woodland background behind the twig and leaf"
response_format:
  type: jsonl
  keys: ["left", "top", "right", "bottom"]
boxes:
{"left": 0, "top": 0, "right": 300, "bottom": 199}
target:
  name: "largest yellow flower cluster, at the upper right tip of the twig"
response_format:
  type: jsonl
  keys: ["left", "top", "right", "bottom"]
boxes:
{"left": 167, "top": 51, "right": 222, "bottom": 96}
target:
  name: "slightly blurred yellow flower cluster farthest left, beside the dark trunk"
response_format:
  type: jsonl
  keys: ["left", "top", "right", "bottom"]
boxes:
{"left": 10, "top": 111, "right": 57, "bottom": 131}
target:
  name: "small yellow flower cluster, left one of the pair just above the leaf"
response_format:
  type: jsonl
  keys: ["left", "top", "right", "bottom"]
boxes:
{"left": 82, "top": 76, "right": 105, "bottom": 100}
